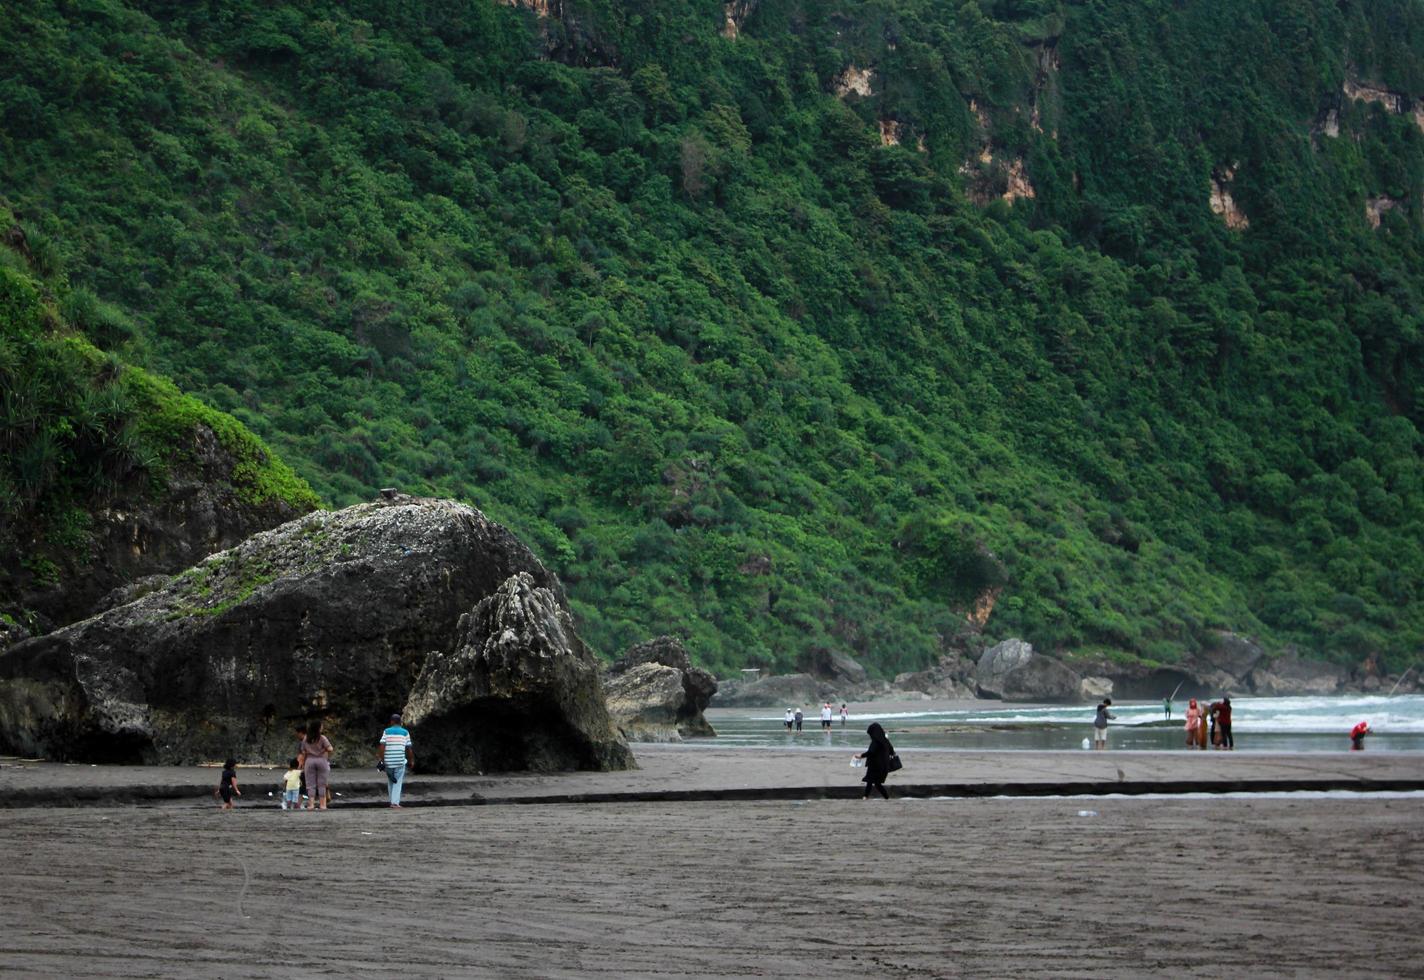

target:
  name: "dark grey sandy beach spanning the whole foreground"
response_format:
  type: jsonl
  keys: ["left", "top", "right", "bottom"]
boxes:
{"left": 0, "top": 748, "right": 1424, "bottom": 977}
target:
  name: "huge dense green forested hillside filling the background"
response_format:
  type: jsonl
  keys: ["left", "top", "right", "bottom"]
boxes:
{"left": 0, "top": 0, "right": 1424, "bottom": 671}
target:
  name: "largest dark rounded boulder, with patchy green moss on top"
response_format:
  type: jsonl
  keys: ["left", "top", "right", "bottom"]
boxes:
{"left": 0, "top": 497, "right": 619, "bottom": 765}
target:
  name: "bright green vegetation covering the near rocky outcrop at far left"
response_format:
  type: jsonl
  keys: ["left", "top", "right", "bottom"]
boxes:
{"left": 0, "top": 208, "right": 319, "bottom": 601}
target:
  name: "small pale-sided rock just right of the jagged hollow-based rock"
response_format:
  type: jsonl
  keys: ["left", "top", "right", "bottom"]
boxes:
{"left": 604, "top": 637, "right": 718, "bottom": 742}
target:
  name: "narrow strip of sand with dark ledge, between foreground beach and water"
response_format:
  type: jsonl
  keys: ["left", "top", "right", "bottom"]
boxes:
{"left": 0, "top": 744, "right": 1424, "bottom": 812}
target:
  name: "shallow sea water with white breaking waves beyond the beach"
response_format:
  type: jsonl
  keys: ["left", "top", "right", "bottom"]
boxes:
{"left": 706, "top": 694, "right": 1424, "bottom": 752}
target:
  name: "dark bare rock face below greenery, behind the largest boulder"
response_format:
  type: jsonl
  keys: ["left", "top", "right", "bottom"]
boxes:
{"left": 0, "top": 424, "right": 311, "bottom": 630}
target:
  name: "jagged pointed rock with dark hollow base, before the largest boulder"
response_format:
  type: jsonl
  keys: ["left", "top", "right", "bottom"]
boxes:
{"left": 402, "top": 571, "right": 632, "bottom": 772}
